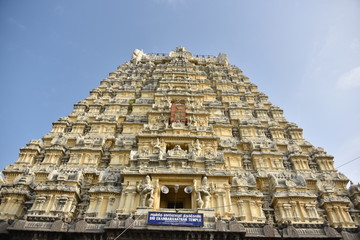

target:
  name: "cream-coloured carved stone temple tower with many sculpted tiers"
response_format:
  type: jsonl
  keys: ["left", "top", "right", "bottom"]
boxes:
{"left": 0, "top": 47, "right": 360, "bottom": 240}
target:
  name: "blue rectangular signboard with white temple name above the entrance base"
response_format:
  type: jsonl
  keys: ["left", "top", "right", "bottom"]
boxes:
{"left": 148, "top": 212, "right": 204, "bottom": 227}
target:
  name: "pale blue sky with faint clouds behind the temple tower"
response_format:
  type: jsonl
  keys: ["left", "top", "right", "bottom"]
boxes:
{"left": 0, "top": 0, "right": 360, "bottom": 182}
